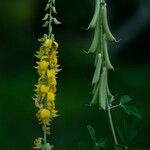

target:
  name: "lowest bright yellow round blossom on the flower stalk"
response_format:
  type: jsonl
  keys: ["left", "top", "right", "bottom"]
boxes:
{"left": 36, "top": 108, "right": 51, "bottom": 125}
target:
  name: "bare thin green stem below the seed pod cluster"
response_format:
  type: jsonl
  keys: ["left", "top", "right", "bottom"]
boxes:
{"left": 107, "top": 102, "right": 118, "bottom": 145}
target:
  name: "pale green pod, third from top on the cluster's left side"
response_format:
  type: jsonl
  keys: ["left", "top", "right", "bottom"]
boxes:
{"left": 92, "top": 53, "right": 102, "bottom": 84}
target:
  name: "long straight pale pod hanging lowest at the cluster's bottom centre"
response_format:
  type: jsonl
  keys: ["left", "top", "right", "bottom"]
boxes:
{"left": 99, "top": 67, "right": 107, "bottom": 110}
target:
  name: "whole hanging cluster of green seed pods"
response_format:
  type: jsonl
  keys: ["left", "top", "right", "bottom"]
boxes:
{"left": 88, "top": 0, "right": 116, "bottom": 110}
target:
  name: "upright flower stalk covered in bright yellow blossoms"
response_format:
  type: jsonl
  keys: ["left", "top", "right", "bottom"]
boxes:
{"left": 33, "top": 0, "right": 60, "bottom": 150}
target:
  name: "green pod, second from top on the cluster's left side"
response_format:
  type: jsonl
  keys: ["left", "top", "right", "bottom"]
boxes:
{"left": 88, "top": 23, "right": 100, "bottom": 53}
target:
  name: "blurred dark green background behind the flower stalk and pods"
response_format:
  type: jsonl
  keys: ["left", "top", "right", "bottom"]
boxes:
{"left": 0, "top": 0, "right": 150, "bottom": 150}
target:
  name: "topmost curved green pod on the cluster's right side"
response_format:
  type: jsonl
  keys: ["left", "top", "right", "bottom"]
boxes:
{"left": 101, "top": 3, "right": 116, "bottom": 41}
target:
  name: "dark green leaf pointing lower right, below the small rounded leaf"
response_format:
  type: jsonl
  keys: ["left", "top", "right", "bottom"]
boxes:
{"left": 121, "top": 105, "right": 142, "bottom": 119}
